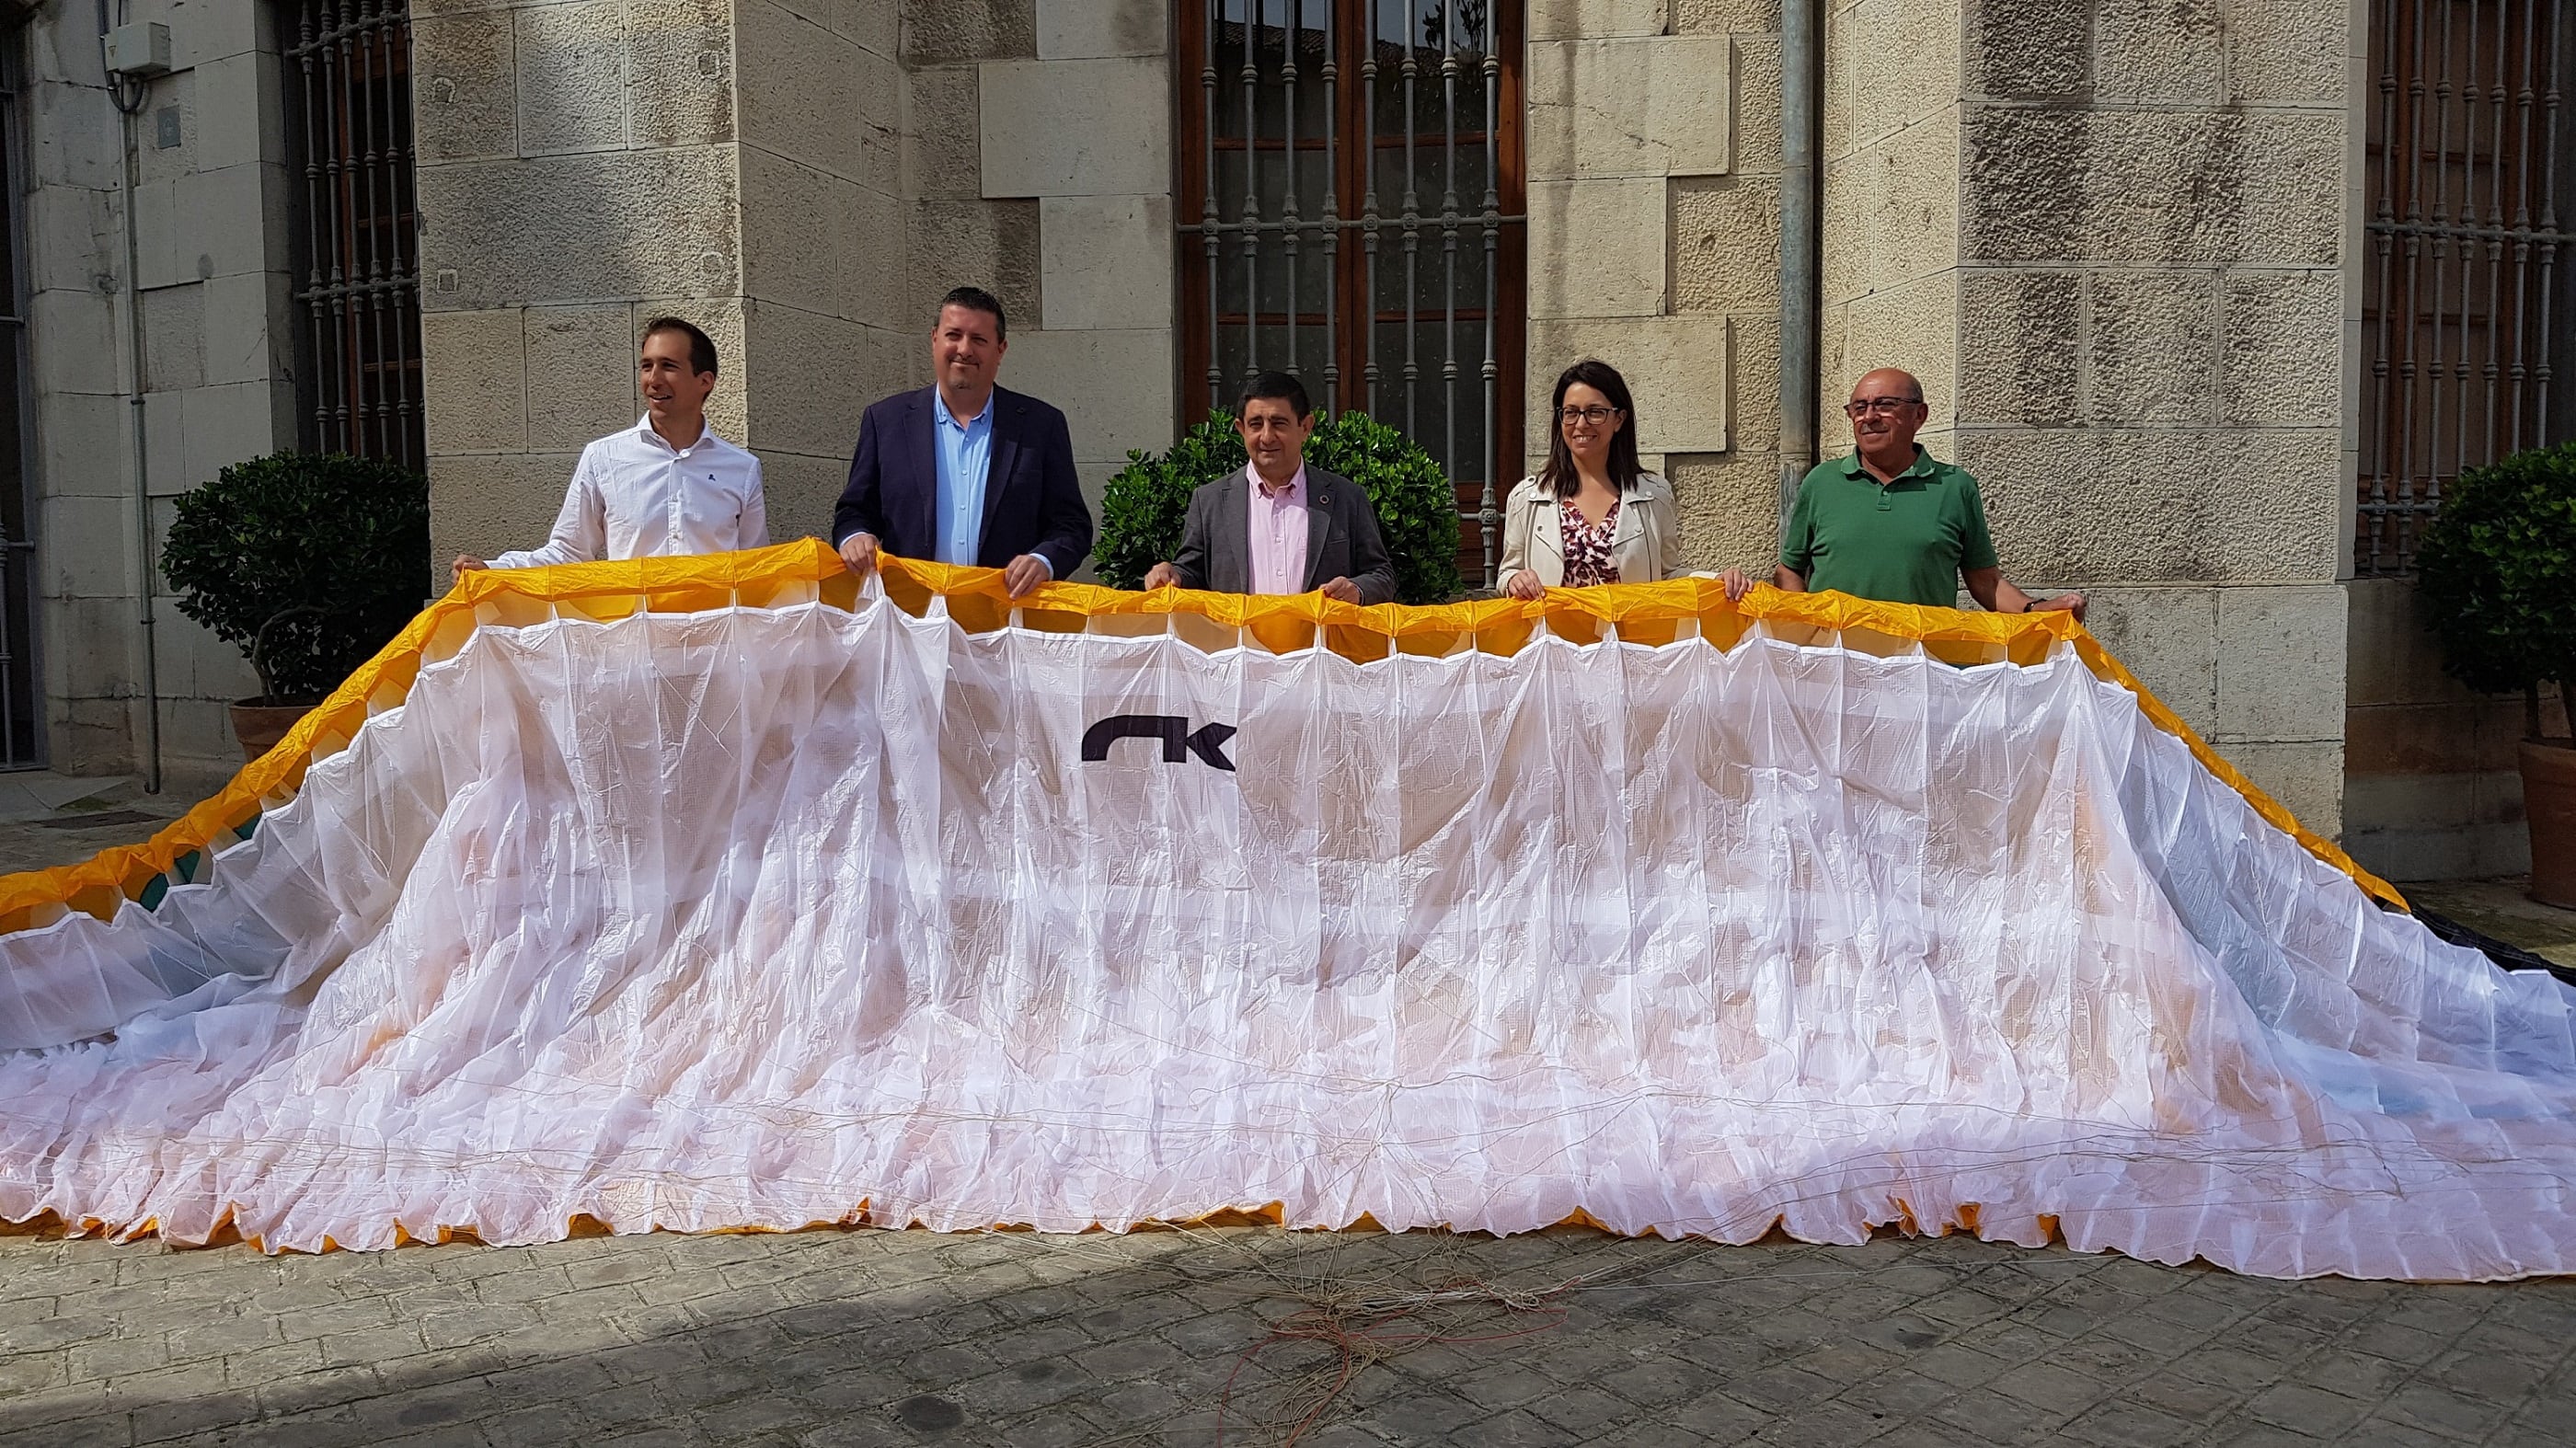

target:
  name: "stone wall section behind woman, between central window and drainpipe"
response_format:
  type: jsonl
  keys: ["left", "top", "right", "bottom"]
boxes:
{"left": 1525, "top": 0, "right": 1780, "bottom": 569}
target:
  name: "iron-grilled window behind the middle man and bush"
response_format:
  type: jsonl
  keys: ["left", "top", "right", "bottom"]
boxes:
{"left": 1175, "top": 0, "right": 1525, "bottom": 585}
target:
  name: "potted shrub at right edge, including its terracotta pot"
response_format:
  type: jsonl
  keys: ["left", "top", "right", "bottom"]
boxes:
{"left": 2416, "top": 443, "right": 2576, "bottom": 907}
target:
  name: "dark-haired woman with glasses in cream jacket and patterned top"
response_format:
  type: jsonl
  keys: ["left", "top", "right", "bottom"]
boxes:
{"left": 1500, "top": 358, "right": 1682, "bottom": 598}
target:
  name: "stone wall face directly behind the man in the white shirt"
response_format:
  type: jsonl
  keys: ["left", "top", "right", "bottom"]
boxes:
{"left": 412, "top": 0, "right": 767, "bottom": 561}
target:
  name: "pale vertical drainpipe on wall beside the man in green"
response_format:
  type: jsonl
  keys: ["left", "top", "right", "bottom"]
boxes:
{"left": 1780, "top": 0, "right": 1823, "bottom": 531}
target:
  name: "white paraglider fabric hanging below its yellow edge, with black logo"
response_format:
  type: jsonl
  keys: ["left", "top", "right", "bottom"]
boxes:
{"left": 0, "top": 601, "right": 2576, "bottom": 1278}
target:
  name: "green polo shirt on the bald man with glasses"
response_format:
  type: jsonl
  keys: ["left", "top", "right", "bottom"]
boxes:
{"left": 1780, "top": 446, "right": 1994, "bottom": 608}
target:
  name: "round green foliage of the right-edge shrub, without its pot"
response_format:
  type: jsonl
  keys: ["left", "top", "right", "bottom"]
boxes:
{"left": 2416, "top": 443, "right": 2576, "bottom": 737}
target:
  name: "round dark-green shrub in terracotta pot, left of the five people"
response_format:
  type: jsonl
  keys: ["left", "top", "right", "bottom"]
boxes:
{"left": 162, "top": 454, "right": 431, "bottom": 760}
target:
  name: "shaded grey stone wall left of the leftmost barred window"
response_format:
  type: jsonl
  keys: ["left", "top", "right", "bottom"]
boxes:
{"left": 13, "top": 0, "right": 302, "bottom": 791}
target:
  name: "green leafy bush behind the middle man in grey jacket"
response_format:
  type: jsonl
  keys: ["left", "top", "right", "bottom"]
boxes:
{"left": 1092, "top": 412, "right": 1458, "bottom": 603}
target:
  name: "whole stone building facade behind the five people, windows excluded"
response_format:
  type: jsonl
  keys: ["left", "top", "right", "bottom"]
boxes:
{"left": 13, "top": 0, "right": 2565, "bottom": 876}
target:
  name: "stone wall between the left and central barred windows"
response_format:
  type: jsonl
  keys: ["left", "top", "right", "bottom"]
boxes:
{"left": 415, "top": 0, "right": 1175, "bottom": 577}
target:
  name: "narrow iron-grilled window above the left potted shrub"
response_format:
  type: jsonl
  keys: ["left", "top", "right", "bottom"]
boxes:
{"left": 281, "top": 0, "right": 425, "bottom": 466}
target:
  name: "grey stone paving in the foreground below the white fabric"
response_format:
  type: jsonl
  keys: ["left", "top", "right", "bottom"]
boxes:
{"left": 0, "top": 1226, "right": 2576, "bottom": 1448}
